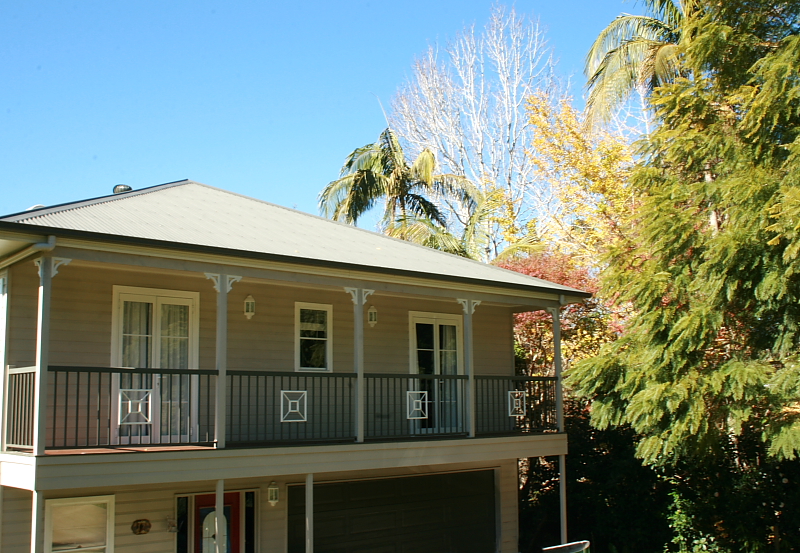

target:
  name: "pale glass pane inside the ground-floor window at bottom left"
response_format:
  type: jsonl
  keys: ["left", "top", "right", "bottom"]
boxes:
{"left": 52, "top": 503, "right": 108, "bottom": 551}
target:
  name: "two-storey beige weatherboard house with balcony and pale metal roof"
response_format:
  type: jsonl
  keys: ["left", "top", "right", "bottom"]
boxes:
{"left": 0, "top": 181, "right": 588, "bottom": 553}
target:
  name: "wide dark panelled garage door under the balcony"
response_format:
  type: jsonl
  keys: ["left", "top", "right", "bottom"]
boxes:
{"left": 289, "top": 470, "right": 496, "bottom": 553}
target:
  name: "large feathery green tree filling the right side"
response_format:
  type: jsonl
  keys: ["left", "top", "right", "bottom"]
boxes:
{"left": 570, "top": 0, "right": 800, "bottom": 464}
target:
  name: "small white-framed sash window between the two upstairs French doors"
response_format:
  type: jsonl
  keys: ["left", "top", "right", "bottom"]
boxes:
{"left": 294, "top": 302, "right": 333, "bottom": 371}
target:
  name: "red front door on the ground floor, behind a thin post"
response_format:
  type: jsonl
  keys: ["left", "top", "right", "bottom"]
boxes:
{"left": 194, "top": 492, "right": 242, "bottom": 553}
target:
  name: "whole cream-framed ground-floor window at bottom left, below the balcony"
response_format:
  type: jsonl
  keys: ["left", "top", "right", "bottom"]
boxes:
{"left": 44, "top": 495, "right": 114, "bottom": 553}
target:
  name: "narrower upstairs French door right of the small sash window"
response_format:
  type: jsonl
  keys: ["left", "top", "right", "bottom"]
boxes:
{"left": 411, "top": 312, "right": 465, "bottom": 434}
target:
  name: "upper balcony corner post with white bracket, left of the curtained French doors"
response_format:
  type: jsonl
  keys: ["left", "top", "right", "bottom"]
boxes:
{"left": 33, "top": 254, "right": 72, "bottom": 455}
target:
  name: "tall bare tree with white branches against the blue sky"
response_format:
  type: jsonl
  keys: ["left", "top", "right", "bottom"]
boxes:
{"left": 389, "top": 6, "right": 563, "bottom": 259}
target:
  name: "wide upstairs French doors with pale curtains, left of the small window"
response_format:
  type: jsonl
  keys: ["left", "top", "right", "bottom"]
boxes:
{"left": 112, "top": 286, "right": 198, "bottom": 444}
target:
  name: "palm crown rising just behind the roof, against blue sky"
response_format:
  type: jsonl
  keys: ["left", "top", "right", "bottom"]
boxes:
{"left": 319, "top": 129, "right": 474, "bottom": 234}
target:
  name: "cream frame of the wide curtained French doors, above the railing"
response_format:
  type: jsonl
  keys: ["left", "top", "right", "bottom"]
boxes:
{"left": 111, "top": 285, "right": 200, "bottom": 369}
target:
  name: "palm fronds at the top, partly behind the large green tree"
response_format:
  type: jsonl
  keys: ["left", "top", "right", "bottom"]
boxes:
{"left": 585, "top": 0, "right": 694, "bottom": 123}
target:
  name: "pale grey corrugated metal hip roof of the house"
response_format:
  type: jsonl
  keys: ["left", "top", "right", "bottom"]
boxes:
{"left": 0, "top": 180, "right": 587, "bottom": 296}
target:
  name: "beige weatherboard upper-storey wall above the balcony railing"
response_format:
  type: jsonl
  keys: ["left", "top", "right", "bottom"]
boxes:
{"left": 8, "top": 260, "right": 514, "bottom": 374}
